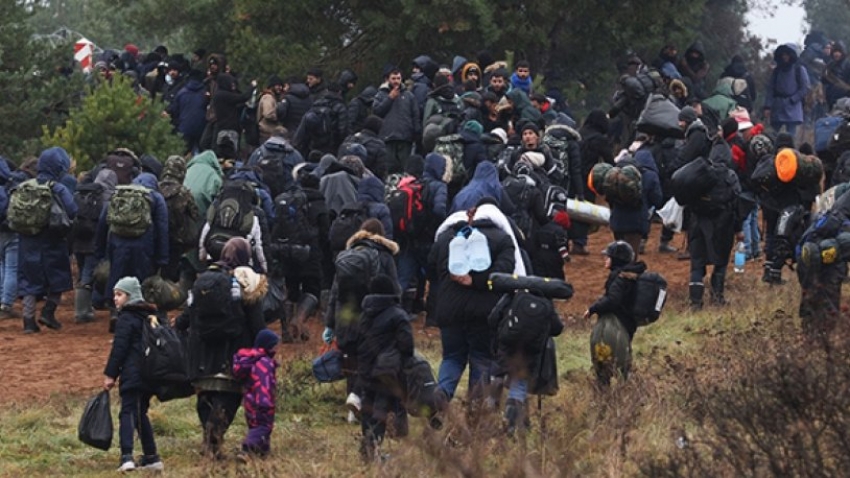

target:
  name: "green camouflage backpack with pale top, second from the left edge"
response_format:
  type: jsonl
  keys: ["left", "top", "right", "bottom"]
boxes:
{"left": 106, "top": 184, "right": 153, "bottom": 238}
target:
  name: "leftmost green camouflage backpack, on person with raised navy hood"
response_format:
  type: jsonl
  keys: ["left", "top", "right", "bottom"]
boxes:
{"left": 6, "top": 179, "right": 53, "bottom": 236}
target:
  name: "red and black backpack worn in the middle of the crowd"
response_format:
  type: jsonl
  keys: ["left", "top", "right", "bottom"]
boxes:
{"left": 387, "top": 176, "right": 430, "bottom": 237}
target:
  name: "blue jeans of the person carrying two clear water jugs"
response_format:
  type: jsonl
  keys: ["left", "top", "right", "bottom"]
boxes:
{"left": 437, "top": 321, "right": 493, "bottom": 398}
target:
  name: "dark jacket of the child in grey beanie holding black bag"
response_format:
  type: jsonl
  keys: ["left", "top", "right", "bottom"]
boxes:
{"left": 103, "top": 302, "right": 156, "bottom": 393}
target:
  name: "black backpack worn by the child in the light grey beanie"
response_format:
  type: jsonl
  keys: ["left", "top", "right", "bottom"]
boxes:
{"left": 140, "top": 315, "right": 189, "bottom": 385}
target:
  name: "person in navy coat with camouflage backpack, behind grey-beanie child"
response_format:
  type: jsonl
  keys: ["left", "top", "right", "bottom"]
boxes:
{"left": 96, "top": 173, "right": 168, "bottom": 330}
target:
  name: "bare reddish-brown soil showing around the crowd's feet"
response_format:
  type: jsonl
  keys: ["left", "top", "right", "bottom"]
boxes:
{"left": 0, "top": 224, "right": 720, "bottom": 404}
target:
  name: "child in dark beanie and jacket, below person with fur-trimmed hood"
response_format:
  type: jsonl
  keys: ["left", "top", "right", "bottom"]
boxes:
{"left": 357, "top": 275, "right": 413, "bottom": 463}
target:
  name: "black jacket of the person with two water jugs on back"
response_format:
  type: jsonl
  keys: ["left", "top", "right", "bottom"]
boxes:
{"left": 428, "top": 220, "right": 515, "bottom": 327}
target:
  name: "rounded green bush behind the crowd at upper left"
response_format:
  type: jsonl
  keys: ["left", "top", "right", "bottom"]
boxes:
{"left": 42, "top": 76, "right": 185, "bottom": 170}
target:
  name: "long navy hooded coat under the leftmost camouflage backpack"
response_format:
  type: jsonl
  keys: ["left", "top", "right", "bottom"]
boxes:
{"left": 18, "top": 147, "right": 77, "bottom": 296}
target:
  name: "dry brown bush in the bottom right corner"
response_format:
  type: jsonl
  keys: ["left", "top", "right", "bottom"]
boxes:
{"left": 643, "top": 314, "right": 850, "bottom": 477}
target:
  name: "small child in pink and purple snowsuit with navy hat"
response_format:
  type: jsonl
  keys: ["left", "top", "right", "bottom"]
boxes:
{"left": 233, "top": 329, "right": 280, "bottom": 461}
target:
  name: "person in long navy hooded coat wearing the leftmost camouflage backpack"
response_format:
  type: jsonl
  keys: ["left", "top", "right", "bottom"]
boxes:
{"left": 14, "top": 147, "right": 77, "bottom": 334}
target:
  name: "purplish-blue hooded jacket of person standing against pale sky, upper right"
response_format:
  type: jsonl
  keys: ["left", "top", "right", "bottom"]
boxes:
{"left": 764, "top": 43, "right": 810, "bottom": 123}
